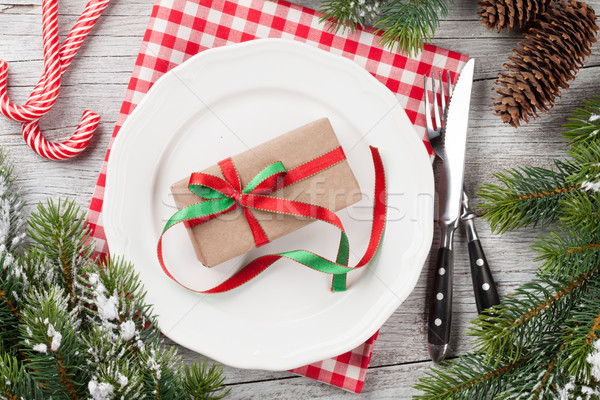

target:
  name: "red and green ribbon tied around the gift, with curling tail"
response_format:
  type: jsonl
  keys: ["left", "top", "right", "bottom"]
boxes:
{"left": 157, "top": 147, "right": 387, "bottom": 293}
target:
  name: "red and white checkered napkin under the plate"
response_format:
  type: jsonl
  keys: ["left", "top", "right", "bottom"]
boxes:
{"left": 88, "top": 0, "right": 468, "bottom": 393}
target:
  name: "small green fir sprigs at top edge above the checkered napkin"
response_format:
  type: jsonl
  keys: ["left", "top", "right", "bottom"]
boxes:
{"left": 321, "top": 0, "right": 449, "bottom": 55}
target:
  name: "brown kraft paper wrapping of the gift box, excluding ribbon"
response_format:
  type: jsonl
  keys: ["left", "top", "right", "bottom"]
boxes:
{"left": 171, "top": 118, "right": 361, "bottom": 267}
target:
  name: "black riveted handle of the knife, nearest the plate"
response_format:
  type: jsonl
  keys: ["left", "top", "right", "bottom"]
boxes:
{"left": 428, "top": 247, "right": 454, "bottom": 345}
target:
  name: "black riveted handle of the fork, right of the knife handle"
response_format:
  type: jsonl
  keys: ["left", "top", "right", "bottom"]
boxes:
{"left": 469, "top": 239, "right": 500, "bottom": 314}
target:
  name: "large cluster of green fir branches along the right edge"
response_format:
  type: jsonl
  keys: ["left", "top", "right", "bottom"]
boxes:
{"left": 415, "top": 96, "right": 600, "bottom": 400}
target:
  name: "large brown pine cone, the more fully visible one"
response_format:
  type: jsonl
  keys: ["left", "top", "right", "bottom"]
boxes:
{"left": 493, "top": 0, "right": 598, "bottom": 127}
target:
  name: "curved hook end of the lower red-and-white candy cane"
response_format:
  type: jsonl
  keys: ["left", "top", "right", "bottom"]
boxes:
{"left": 23, "top": 110, "right": 100, "bottom": 160}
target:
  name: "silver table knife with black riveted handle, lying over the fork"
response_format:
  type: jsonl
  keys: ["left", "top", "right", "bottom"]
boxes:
{"left": 428, "top": 59, "right": 475, "bottom": 363}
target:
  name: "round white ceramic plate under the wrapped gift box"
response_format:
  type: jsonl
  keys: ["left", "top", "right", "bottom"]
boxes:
{"left": 104, "top": 39, "right": 434, "bottom": 370}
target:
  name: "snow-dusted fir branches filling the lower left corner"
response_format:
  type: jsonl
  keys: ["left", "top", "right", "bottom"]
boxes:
{"left": 0, "top": 151, "right": 228, "bottom": 400}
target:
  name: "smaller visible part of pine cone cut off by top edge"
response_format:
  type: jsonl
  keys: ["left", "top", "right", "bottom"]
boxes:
{"left": 478, "top": 0, "right": 554, "bottom": 32}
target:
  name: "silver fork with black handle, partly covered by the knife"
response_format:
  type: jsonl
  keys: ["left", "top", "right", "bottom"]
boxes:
{"left": 423, "top": 70, "right": 500, "bottom": 322}
